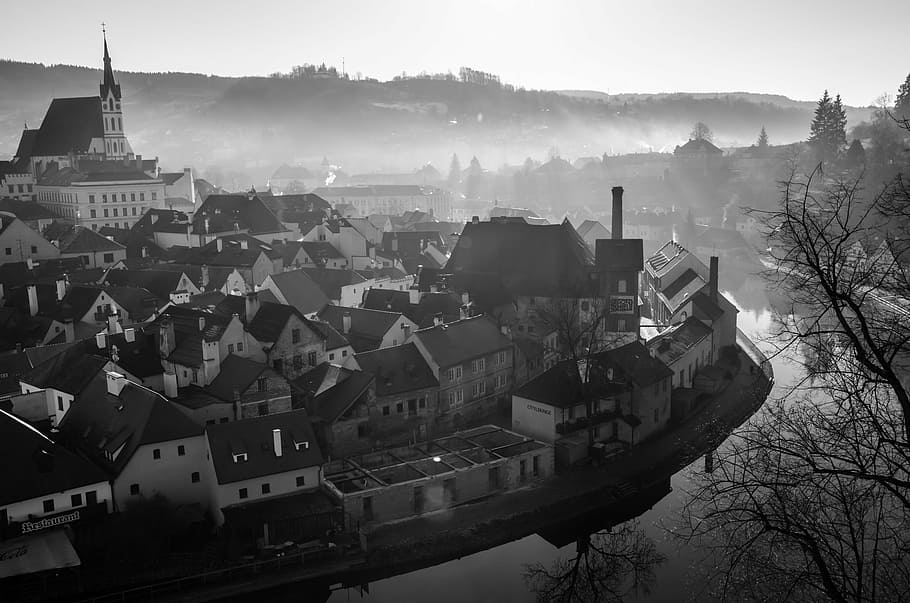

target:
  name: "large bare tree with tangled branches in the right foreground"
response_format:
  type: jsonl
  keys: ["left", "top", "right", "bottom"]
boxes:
{"left": 677, "top": 162, "right": 910, "bottom": 601}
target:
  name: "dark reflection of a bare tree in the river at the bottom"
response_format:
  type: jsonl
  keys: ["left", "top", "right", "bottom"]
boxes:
{"left": 524, "top": 521, "right": 666, "bottom": 603}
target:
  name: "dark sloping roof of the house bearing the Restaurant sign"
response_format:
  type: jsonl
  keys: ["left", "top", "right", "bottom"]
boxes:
{"left": 0, "top": 410, "right": 108, "bottom": 506}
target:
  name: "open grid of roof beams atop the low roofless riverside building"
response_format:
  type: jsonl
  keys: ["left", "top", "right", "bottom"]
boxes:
{"left": 323, "top": 425, "right": 547, "bottom": 494}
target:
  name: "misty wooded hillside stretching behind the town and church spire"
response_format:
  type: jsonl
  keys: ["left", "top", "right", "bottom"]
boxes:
{"left": 0, "top": 61, "right": 868, "bottom": 182}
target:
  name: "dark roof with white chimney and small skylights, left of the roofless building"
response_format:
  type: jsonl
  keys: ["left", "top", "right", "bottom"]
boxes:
{"left": 206, "top": 410, "right": 323, "bottom": 484}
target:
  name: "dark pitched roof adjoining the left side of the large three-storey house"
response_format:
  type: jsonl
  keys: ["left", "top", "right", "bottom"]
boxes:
{"left": 355, "top": 343, "right": 439, "bottom": 396}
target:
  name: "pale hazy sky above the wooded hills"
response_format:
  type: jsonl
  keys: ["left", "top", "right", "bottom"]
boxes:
{"left": 0, "top": 0, "right": 910, "bottom": 105}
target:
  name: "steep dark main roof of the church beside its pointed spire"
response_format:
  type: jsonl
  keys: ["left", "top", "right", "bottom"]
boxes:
{"left": 30, "top": 96, "right": 104, "bottom": 157}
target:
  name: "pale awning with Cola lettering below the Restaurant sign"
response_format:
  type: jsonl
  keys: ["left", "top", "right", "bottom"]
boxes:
{"left": 0, "top": 530, "right": 82, "bottom": 578}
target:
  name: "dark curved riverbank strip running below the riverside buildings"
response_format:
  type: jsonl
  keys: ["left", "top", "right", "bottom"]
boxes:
{"left": 139, "top": 340, "right": 773, "bottom": 603}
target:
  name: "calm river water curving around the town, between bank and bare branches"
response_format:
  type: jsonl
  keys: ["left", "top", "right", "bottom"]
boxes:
{"left": 329, "top": 274, "right": 797, "bottom": 603}
